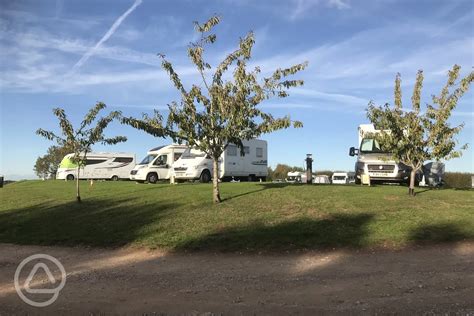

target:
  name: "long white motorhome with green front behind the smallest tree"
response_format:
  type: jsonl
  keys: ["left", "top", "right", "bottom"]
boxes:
{"left": 56, "top": 153, "right": 135, "bottom": 181}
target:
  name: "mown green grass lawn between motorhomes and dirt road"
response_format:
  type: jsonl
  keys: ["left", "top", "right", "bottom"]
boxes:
{"left": 0, "top": 181, "right": 474, "bottom": 251}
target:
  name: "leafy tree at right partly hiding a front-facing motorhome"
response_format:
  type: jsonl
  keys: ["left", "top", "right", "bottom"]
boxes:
{"left": 367, "top": 65, "right": 474, "bottom": 196}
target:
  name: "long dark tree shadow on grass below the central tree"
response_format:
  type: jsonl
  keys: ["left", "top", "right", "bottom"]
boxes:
{"left": 174, "top": 213, "right": 373, "bottom": 252}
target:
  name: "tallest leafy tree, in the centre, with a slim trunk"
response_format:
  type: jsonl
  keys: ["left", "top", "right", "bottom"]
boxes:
{"left": 123, "top": 16, "right": 307, "bottom": 202}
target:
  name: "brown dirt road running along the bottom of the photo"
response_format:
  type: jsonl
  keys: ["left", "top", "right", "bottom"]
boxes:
{"left": 0, "top": 243, "right": 474, "bottom": 315}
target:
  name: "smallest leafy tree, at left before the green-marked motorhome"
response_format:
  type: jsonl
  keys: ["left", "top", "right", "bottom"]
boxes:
{"left": 36, "top": 102, "right": 127, "bottom": 202}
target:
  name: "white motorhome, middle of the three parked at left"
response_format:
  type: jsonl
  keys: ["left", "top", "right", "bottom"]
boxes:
{"left": 130, "top": 144, "right": 188, "bottom": 183}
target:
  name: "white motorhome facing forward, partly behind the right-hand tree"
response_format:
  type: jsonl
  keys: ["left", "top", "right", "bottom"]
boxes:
{"left": 349, "top": 124, "right": 411, "bottom": 184}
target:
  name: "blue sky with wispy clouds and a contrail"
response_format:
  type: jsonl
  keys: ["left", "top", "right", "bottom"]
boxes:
{"left": 0, "top": 0, "right": 474, "bottom": 179}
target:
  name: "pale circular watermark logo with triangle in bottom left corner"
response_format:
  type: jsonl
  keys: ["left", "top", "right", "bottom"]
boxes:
{"left": 14, "top": 254, "right": 66, "bottom": 307}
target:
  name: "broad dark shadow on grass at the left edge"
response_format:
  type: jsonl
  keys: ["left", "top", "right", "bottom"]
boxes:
{"left": 0, "top": 198, "right": 179, "bottom": 247}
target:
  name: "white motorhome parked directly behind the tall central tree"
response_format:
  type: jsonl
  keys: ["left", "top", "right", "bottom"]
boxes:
{"left": 173, "top": 139, "right": 268, "bottom": 182}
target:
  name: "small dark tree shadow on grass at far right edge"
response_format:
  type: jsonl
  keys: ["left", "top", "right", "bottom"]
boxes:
{"left": 408, "top": 223, "right": 474, "bottom": 244}
